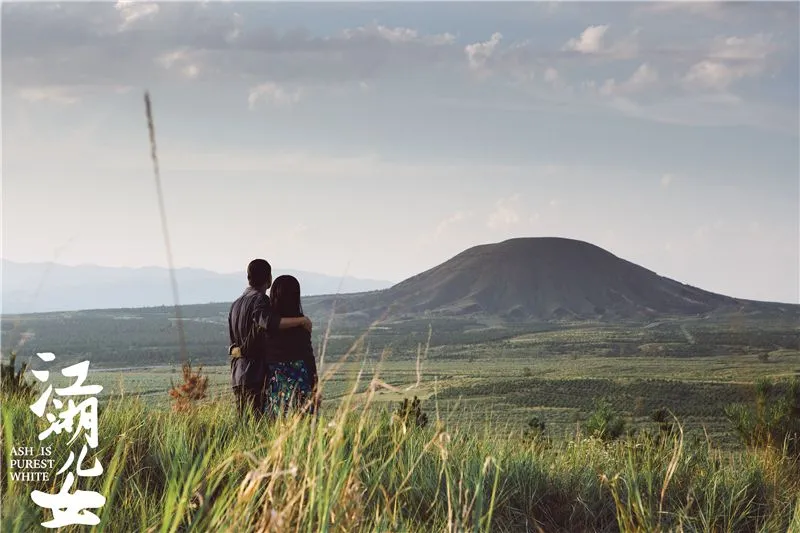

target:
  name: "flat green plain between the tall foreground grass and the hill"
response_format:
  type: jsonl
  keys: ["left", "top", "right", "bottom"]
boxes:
{"left": 4, "top": 306, "right": 800, "bottom": 447}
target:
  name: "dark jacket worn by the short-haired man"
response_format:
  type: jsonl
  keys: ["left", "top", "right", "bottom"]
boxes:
{"left": 228, "top": 287, "right": 281, "bottom": 388}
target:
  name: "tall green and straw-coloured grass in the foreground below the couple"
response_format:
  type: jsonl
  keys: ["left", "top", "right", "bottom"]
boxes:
{"left": 0, "top": 382, "right": 800, "bottom": 533}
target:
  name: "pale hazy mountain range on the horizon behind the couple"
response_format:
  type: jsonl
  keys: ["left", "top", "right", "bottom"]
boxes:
{"left": 0, "top": 260, "right": 392, "bottom": 314}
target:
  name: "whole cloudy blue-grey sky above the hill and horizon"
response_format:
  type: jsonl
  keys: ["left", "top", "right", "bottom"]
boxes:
{"left": 0, "top": 1, "right": 800, "bottom": 303}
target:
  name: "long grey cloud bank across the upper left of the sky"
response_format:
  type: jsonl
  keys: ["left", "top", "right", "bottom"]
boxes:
{"left": 3, "top": 2, "right": 463, "bottom": 91}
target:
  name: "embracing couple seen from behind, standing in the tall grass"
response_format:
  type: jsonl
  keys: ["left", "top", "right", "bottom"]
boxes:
{"left": 228, "top": 259, "right": 320, "bottom": 419}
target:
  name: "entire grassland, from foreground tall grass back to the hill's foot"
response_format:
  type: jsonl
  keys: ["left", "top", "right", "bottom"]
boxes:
{"left": 3, "top": 311, "right": 800, "bottom": 531}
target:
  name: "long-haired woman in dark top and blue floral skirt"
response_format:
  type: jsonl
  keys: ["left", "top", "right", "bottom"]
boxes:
{"left": 264, "top": 276, "right": 319, "bottom": 418}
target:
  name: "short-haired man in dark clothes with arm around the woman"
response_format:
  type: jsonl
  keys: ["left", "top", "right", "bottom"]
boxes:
{"left": 228, "top": 259, "right": 311, "bottom": 418}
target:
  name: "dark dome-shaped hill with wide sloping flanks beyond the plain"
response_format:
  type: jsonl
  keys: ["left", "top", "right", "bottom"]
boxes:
{"left": 314, "top": 238, "right": 800, "bottom": 320}
